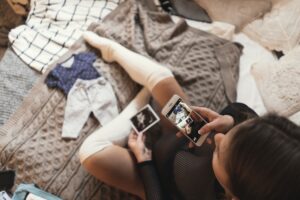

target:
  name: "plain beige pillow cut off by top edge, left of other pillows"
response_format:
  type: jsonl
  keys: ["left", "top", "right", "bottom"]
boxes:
{"left": 195, "top": 0, "right": 272, "bottom": 31}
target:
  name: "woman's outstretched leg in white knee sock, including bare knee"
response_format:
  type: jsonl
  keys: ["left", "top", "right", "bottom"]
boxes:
{"left": 84, "top": 32, "right": 187, "bottom": 106}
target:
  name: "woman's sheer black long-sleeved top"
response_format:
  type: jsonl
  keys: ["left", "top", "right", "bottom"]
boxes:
{"left": 138, "top": 103, "right": 257, "bottom": 200}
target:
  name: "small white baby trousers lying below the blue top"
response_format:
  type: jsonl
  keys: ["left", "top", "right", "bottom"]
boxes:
{"left": 62, "top": 77, "right": 118, "bottom": 138}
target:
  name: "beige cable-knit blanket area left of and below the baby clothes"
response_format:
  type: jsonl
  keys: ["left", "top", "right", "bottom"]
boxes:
{"left": 0, "top": 43, "right": 135, "bottom": 200}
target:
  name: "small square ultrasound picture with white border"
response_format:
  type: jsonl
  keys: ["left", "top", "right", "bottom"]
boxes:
{"left": 130, "top": 104, "right": 159, "bottom": 133}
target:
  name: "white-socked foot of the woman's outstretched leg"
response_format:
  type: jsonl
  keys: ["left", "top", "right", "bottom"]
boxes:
{"left": 83, "top": 31, "right": 121, "bottom": 62}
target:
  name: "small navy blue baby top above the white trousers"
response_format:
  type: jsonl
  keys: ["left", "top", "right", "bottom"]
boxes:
{"left": 46, "top": 52, "right": 100, "bottom": 95}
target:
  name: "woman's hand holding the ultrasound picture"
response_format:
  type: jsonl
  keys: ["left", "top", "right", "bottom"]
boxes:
{"left": 128, "top": 132, "right": 152, "bottom": 163}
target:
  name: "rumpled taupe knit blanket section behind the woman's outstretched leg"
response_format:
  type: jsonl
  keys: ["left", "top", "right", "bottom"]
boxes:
{"left": 89, "top": 0, "right": 241, "bottom": 111}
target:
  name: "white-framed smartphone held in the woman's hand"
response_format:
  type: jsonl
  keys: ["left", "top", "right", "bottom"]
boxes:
{"left": 161, "top": 95, "right": 208, "bottom": 146}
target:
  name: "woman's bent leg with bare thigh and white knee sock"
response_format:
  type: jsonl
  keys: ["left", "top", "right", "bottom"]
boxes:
{"left": 79, "top": 88, "right": 150, "bottom": 198}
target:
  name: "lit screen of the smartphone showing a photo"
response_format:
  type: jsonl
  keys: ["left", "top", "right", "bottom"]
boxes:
{"left": 166, "top": 99, "right": 206, "bottom": 143}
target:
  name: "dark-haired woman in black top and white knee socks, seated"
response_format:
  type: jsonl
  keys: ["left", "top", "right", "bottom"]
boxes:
{"left": 80, "top": 32, "right": 300, "bottom": 200}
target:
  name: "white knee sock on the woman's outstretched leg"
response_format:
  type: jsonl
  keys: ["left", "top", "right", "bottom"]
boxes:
{"left": 83, "top": 32, "right": 173, "bottom": 91}
